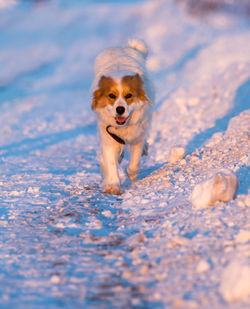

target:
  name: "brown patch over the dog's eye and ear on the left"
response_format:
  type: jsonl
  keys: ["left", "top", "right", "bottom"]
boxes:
{"left": 91, "top": 76, "right": 119, "bottom": 109}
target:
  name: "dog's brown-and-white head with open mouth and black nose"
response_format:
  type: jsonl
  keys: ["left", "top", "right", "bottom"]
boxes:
{"left": 91, "top": 74, "right": 150, "bottom": 126}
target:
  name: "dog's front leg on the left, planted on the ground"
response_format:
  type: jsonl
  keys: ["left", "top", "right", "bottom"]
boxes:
{"left": 102, "top": 145, "right": 122, "bottom": 195}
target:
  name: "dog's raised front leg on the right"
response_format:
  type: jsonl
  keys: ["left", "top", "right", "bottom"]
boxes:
{"left": 127, "top": 141, "right": 144, "bottom": 181}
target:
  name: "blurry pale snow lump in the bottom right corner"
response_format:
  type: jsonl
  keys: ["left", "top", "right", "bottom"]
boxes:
{"left": 220, "top": 260, "right": 250, "bottom": 302}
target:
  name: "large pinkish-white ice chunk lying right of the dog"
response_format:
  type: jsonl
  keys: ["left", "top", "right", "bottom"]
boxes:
{"left": 191, "top": 171, "right": 238, "bottom": 209}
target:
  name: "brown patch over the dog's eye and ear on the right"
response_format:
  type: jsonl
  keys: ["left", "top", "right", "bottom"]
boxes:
{"left": 121, "top": 74, "right": 149, "bottom": 104}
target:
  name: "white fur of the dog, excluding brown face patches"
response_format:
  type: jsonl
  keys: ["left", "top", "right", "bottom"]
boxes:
{"left": 92, "top": 39, "right": 154, "bottom": 194}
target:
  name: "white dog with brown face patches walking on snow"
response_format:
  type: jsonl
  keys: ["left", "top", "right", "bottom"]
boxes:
{"left": 91, "top": 39, "right": 155, "bottom": 195}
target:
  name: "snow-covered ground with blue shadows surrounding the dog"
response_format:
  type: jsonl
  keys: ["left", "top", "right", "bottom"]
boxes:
{"left": 0, "top": 0, "right": 250, "bottom": 308}
